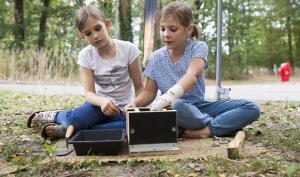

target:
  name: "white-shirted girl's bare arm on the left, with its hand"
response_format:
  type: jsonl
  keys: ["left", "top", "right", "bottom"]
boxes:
{"left": 80, "top": 66, "right": 119, "bottom": 116}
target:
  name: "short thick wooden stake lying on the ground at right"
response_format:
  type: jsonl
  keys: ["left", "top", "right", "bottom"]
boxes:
{"left": 227, "top": 131, "right": 246, "bottom": 159}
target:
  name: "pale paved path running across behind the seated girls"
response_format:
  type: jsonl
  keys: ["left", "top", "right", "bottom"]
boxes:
{"left": 0, "top": 82, "right": 300, "bottom": 101}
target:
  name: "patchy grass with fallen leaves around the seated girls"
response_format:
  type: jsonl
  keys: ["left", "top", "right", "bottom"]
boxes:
{"left": 0, "top": 91, "right": 300, "bottom": 177}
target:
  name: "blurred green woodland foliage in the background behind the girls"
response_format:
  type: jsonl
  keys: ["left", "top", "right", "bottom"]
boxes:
{"left": 0, "top": 0, "right": 300, "bottom": 79}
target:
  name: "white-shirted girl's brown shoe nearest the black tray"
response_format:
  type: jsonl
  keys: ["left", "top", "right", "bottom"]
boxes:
{"left": 41, "top": 123, "right": 67, "bottom": 139}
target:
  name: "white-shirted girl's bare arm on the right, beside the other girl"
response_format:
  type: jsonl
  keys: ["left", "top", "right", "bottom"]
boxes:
{"left": 128, "top": 58, "right": 144, "bottom": 96}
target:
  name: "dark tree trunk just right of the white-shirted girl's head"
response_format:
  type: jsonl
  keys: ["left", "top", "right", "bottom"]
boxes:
{"left": 119, "top": 0, "right": 133, "bottom": 42}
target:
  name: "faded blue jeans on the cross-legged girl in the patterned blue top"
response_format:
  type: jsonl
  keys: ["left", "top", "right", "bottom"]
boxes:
{"left": 173, "top": 99, "right": 260, "bottom": 136}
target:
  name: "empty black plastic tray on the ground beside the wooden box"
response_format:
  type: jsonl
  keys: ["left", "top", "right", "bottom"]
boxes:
{"left": 68, "top": 129, "right": 125, "bottom": 156}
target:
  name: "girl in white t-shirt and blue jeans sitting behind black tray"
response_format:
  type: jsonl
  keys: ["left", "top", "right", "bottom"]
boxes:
{"left": 27, "top": 6, "right": 144, "bottom": 138}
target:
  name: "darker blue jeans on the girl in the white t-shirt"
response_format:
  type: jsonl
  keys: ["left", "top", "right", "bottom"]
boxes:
{"left": 54, "top": 102, "right": 126, "bottom": 131}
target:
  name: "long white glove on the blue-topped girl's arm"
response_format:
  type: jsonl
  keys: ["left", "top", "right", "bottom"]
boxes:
{"left": 151, "top": 84, "right": 184, "bottom": 111}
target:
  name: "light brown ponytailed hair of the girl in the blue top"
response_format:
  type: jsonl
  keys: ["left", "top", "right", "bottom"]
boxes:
{"left": 161, "top": 1, "right": 200, "bottom": 39}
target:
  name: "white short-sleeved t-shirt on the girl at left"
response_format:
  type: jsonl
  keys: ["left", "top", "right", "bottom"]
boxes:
{"left": 77, "top": 39, "right": 141, "bottom": 109}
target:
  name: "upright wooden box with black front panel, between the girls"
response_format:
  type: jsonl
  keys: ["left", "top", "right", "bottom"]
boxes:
{"left": 126, "top": 107, "right": 179, "bottom": 154}
